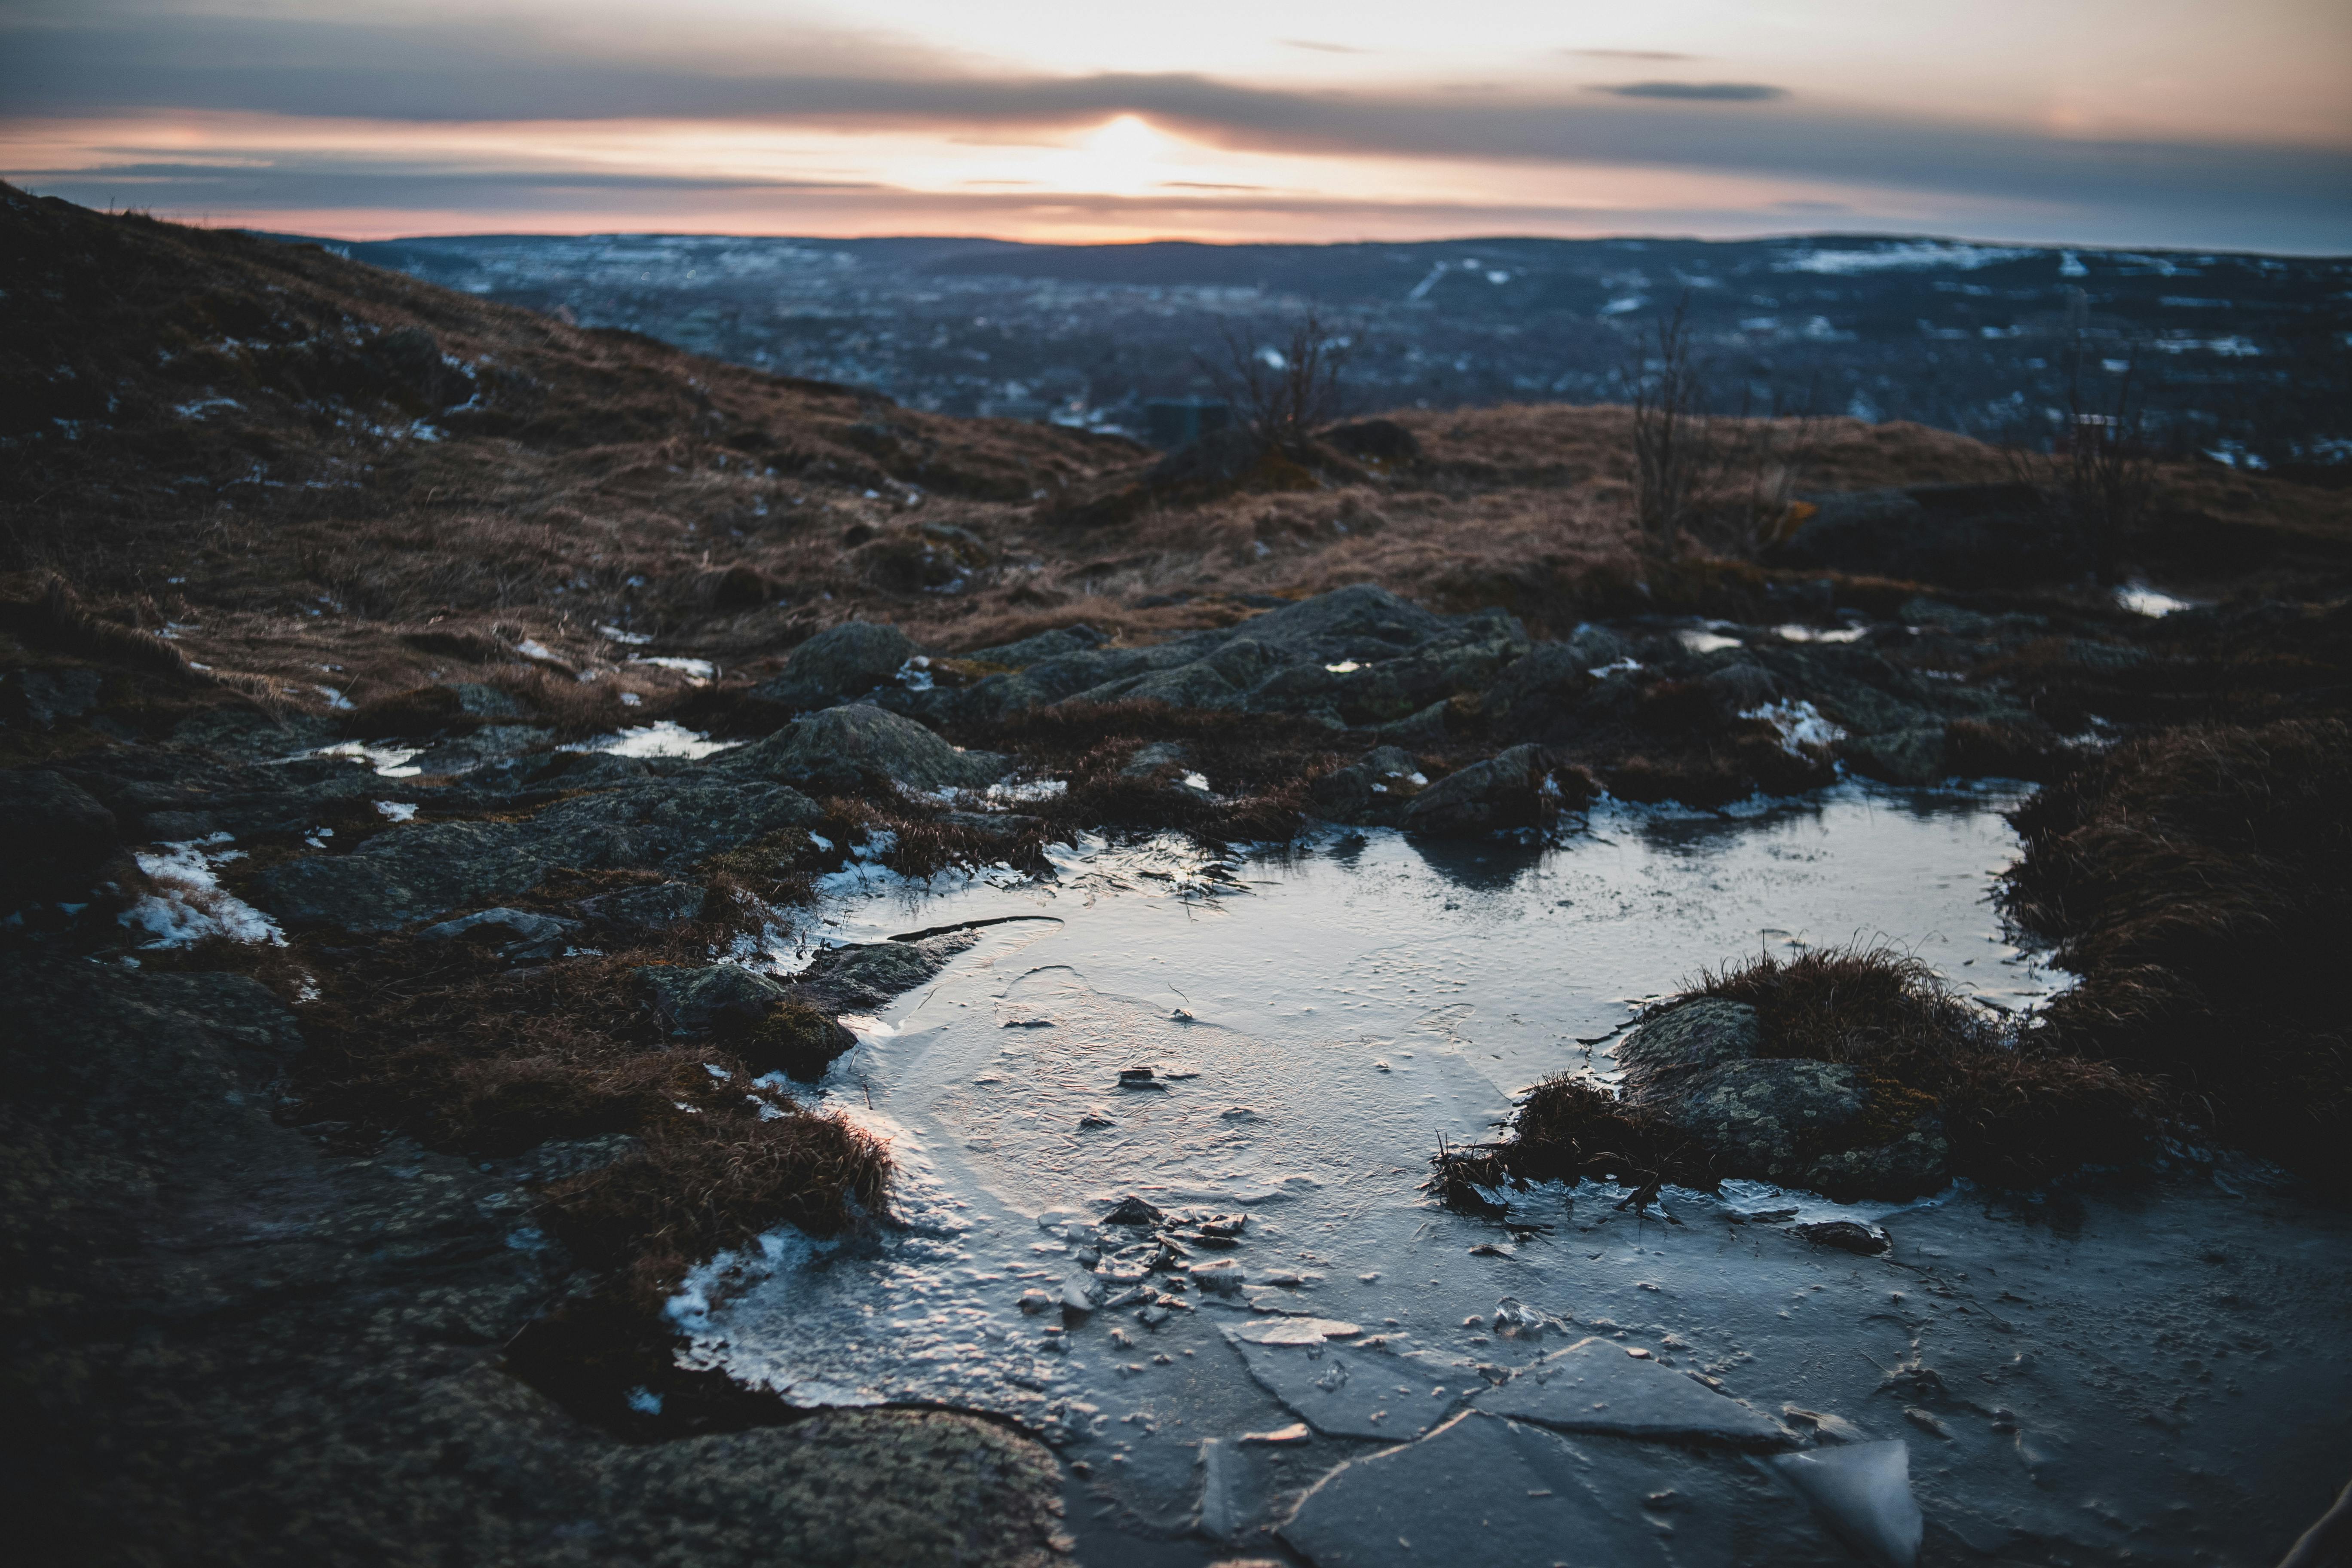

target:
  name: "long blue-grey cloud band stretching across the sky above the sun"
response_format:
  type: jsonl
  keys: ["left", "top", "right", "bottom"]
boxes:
{"left": 0, "top": 16, "right": 2352, "bottom": 242}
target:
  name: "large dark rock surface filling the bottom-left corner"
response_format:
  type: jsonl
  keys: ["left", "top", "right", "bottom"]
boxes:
{"left": 0, "top": 964, "right": 1061, "bottom": 1568}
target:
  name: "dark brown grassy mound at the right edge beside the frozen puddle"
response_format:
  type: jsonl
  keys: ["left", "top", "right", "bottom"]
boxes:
{"left": 2009, "top": 720, "right": 2352, "bottom": 1176}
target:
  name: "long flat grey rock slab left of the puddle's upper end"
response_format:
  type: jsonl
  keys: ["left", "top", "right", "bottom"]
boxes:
{"left": 249, "top": 773, "right": 823, "bottom": 931}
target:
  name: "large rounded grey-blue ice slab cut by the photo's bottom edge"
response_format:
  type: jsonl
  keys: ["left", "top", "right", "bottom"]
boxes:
{"left": 1277, "top": 1411, "right": 1837, "bottom": 1568}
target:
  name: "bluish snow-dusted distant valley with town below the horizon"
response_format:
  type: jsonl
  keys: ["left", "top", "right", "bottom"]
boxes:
{"left": 317, "top": 235, "right": 2352, "bottom": 480}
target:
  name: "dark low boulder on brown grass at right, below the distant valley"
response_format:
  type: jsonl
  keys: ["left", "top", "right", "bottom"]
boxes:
{"left": 1764, "top": 484, "right": 2093, "bottom": 588}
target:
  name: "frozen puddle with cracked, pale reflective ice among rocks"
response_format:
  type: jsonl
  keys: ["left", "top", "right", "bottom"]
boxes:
{"left": 673, "top": 787, "right": 2352, "bottom": 1566}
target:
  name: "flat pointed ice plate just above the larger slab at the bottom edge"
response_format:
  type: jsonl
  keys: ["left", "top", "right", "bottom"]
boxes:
{"left": 1470, "top": 1338, "right": 1788, "bottom": 1448}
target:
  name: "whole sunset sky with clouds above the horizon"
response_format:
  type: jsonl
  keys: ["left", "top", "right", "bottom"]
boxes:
{"left": 0, "top": 0, "right": 2352, "bottom": 254}
